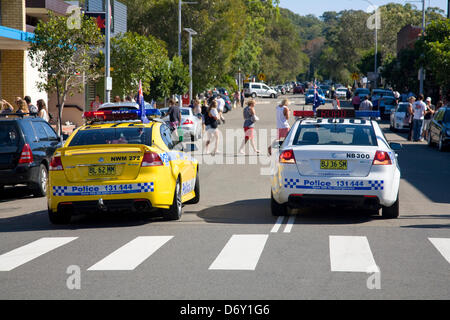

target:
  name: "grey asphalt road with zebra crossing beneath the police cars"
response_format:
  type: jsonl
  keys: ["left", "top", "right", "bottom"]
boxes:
{"left": 0, "top": 96, "right": 450, "bottom": 300}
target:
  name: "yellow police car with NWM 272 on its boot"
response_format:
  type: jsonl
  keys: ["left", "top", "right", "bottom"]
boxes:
{"left": 47, "top": 109, "right": 200, "bottom": 224}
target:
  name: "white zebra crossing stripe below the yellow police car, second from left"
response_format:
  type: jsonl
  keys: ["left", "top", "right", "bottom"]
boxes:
{"left": 88, "top": 236, "right": 173, "bottom": 271}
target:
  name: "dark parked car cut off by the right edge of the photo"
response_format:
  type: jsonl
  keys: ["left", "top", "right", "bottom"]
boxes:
{"left": 428, "top": 107, "right": 450, "bottom": 151}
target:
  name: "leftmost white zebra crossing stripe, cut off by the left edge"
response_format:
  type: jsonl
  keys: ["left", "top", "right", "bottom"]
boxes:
{"left": 0, "top": 237, "right": 77, "bottom": 271}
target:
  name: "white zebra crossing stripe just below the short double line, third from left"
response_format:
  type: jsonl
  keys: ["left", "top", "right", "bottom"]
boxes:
{"left": 209, "top": 234, "right": 269, "bottom": 270}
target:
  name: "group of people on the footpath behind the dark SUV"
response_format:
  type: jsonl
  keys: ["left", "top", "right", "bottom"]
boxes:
{"left": 0, "top": 96, "right": 50, "bottom": 122}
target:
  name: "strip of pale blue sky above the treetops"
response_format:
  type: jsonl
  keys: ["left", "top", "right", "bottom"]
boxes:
{"left": 280, "top": 0, "right": 447, "bottom": 16}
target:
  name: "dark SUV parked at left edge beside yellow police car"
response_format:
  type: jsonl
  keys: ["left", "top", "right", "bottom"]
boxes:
{"left": 0, "top": 114, "right": 61, "bottom": 197}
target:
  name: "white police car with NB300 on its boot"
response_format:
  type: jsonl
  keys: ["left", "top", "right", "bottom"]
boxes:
{"left": 271, "top": 110, "right": 401, "bottom": 218}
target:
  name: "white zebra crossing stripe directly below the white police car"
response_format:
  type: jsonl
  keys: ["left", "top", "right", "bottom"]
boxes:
{"left": 330, "top": 236, "right": 377, "bottom": 272}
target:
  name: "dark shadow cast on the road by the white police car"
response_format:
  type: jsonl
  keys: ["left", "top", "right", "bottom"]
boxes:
{"left": 192, "top": 199, "right": 381, "bottom": 225}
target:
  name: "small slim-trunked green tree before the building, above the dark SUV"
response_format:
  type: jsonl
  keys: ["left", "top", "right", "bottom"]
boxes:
{"left": 28, "top": 12, "right": 103, "bottom": 134}
